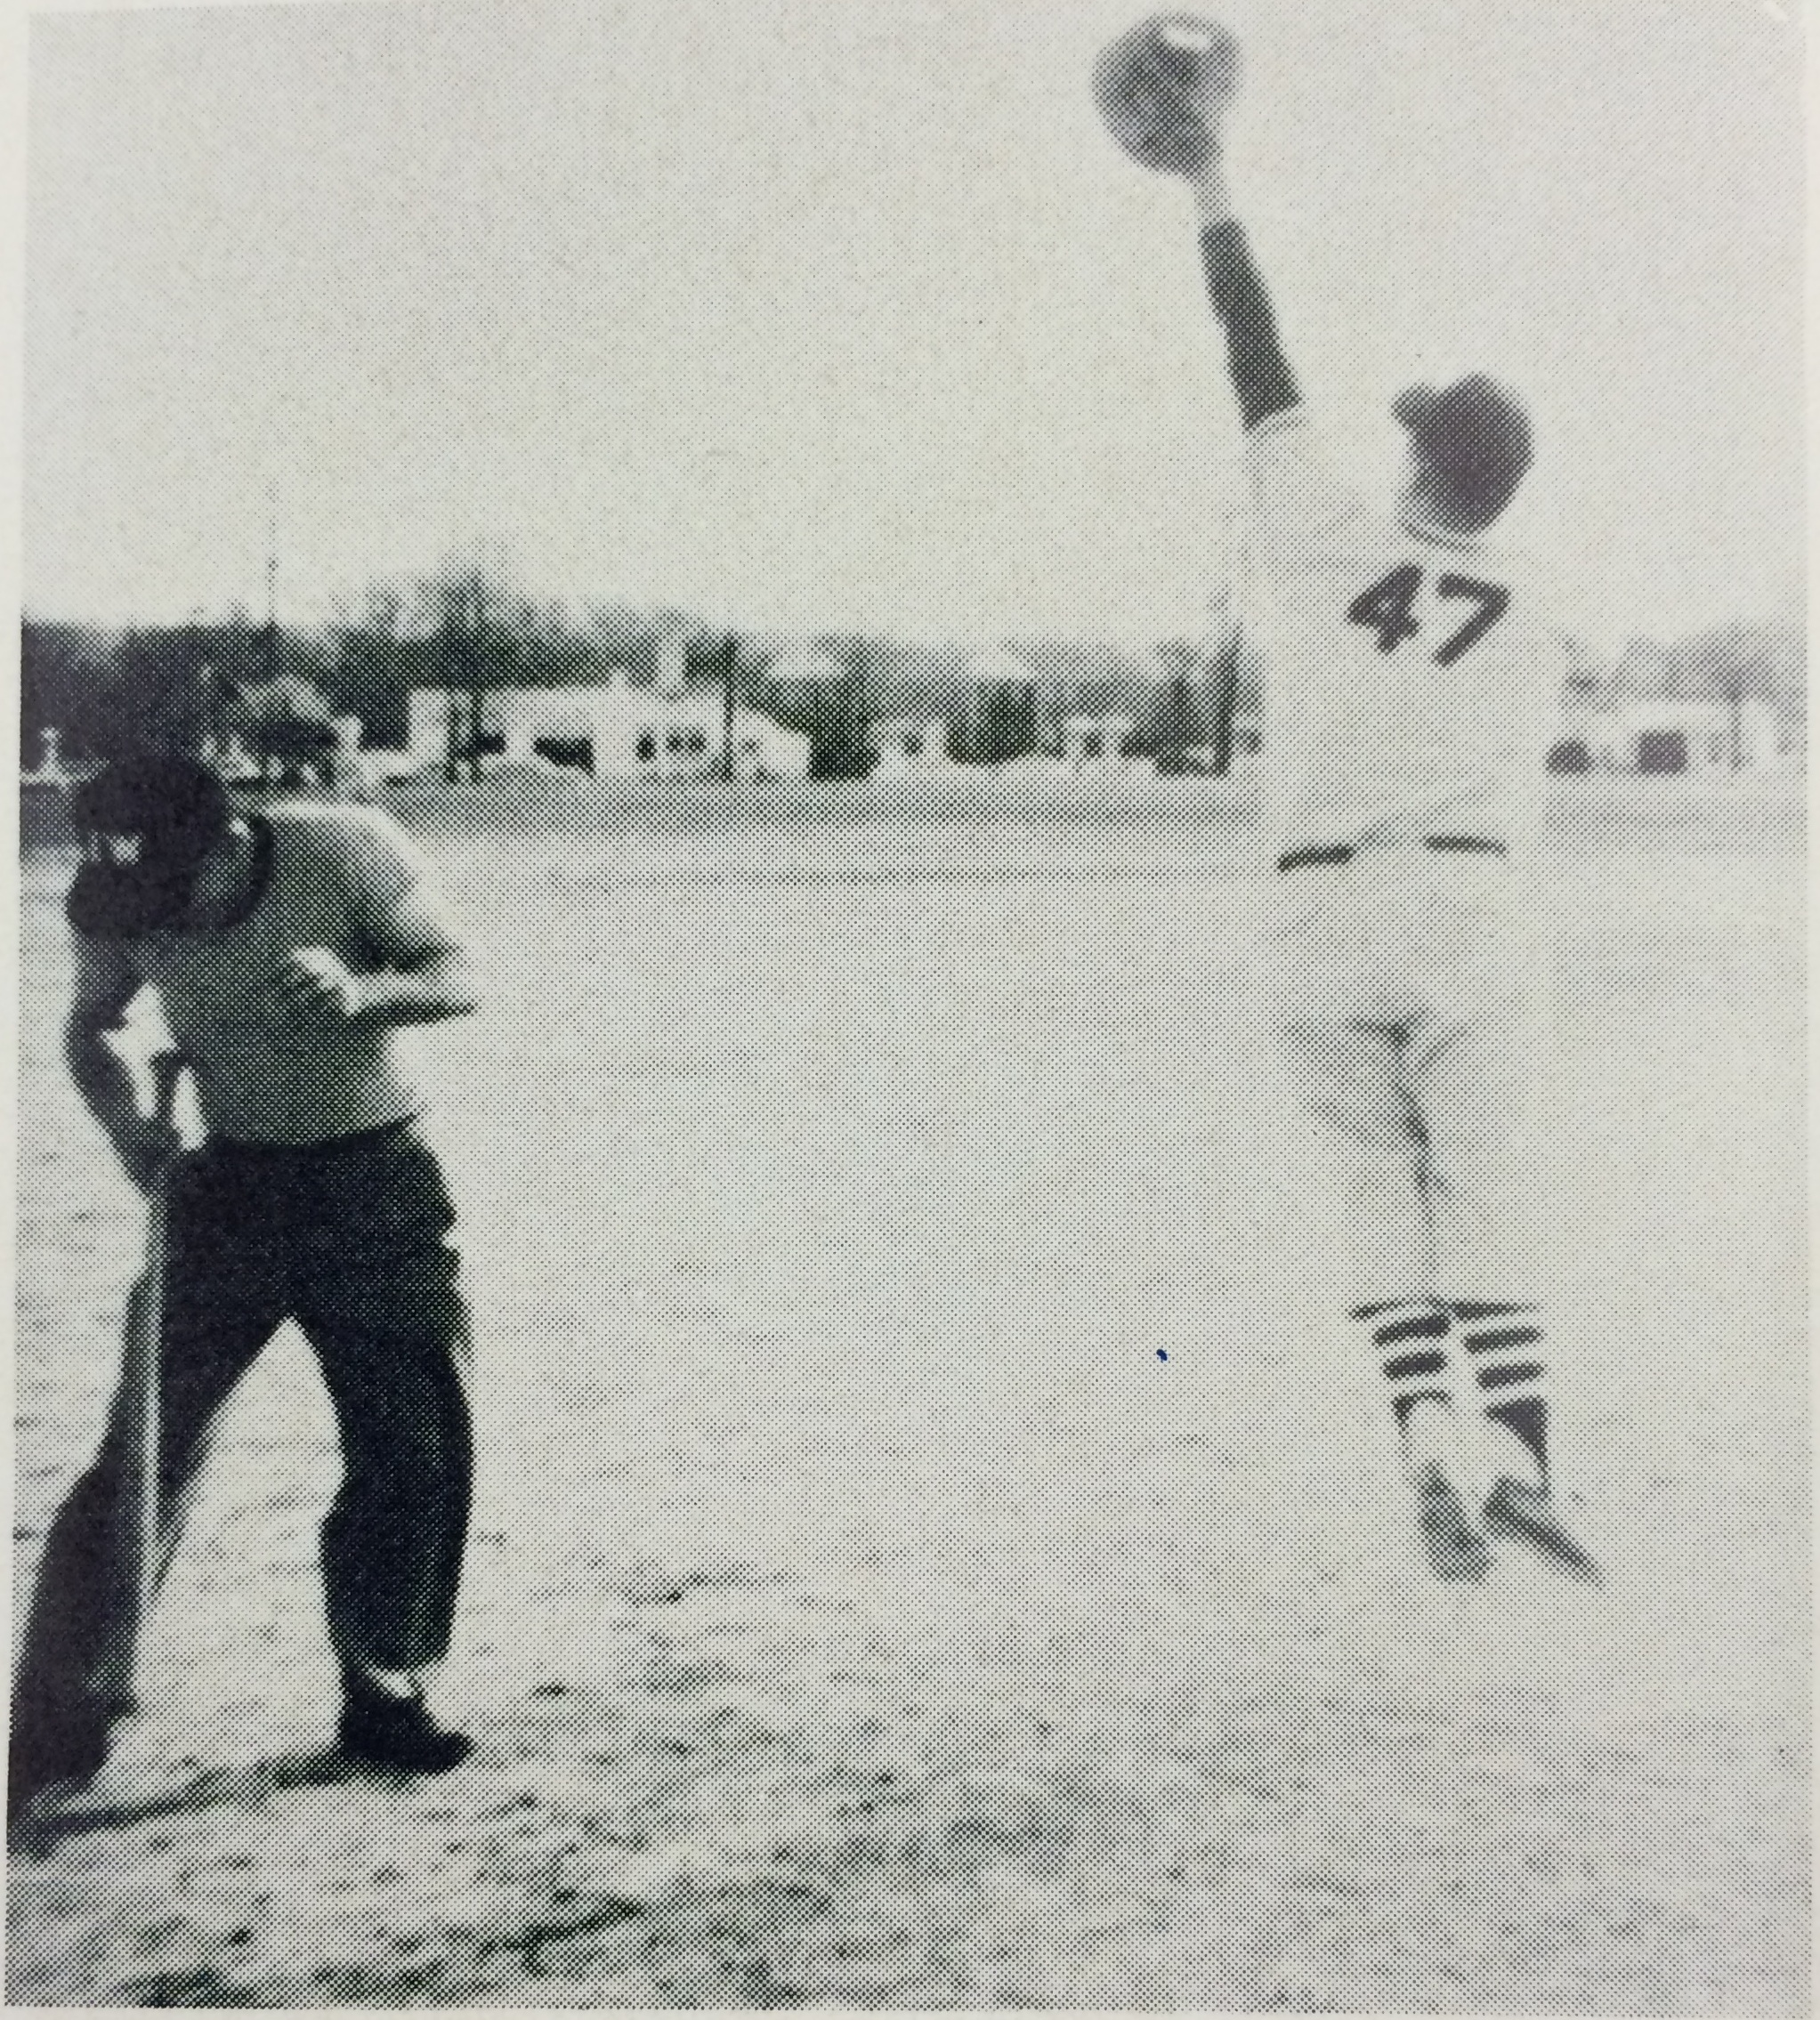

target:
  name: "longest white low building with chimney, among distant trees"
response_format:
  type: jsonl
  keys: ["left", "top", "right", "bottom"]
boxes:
{"left": 410, "top": 675, "right": 808, "bottom": 778}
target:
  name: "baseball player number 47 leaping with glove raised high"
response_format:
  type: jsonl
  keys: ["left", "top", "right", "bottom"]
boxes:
{"left": 1095, "top": 16, "right": 1598, "bottom": 1580}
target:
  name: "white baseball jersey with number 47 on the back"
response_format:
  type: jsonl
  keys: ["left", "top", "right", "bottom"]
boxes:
{"left": 1246, "top": 406, "right": 1559, "bottom": 854}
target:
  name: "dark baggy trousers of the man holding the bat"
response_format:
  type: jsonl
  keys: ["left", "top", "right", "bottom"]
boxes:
{"left": 14, "top": 1123, "right": 473, "bottom": 1729}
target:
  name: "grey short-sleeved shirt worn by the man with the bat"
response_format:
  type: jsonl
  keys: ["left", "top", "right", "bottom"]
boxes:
{"left": 79, "top": 804, "right": 454, "bottom": 1143}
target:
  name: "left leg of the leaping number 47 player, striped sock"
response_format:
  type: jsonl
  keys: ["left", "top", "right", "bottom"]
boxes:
{"left": 1276, "top": 1006, "right": 1489, "bottom": 1578}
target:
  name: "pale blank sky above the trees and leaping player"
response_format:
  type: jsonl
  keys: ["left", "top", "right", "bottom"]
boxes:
{"left": 18, "top": 0, "right": 1806, "bottom": 642}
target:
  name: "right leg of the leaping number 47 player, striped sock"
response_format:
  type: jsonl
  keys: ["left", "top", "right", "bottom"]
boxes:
{"left": 1414, "top": 996, "right": 1598, "bottom": 1580}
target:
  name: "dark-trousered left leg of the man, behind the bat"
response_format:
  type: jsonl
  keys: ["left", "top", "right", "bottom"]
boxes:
{"left": 6, "top": 1151, "right": 283, "bottom": 1816}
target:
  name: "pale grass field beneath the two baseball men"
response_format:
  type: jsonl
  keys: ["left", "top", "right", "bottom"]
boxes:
{"left": 6, "top": 788, "right": 1810, "bottom": 2014}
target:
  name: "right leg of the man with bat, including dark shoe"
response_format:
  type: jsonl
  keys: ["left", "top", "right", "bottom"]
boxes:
{"left": 299, "top": 1131, "right": 473, "bottom": 1772}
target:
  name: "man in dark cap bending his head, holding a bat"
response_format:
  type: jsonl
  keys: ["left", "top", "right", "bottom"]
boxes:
{"left": 8, "top": 755, "right": 486, "bottom": 1818}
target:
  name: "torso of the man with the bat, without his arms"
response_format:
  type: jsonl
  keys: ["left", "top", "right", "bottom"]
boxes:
{"left": 132, "top": 810, "right": 418, "bottom": 1143}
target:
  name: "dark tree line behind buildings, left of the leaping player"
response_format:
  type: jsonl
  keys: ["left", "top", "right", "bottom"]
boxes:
{"left": 20, "top": 571, "right": 1260, "bottom": 778}
